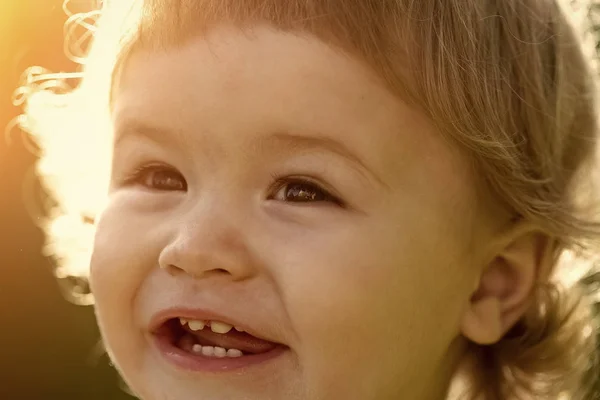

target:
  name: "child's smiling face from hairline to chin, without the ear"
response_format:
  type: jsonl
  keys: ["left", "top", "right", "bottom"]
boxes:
{"left": 91, "top": 25, "right": 485, "bottom": 400}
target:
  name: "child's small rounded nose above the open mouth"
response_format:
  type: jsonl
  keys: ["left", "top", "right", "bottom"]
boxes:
{"left": 158, "top": 200, "right": 257, "bottom": 281}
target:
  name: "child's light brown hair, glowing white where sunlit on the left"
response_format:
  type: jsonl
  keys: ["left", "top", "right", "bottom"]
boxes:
{"left": 11, "top": 0, "right": 600, "bottom": 399}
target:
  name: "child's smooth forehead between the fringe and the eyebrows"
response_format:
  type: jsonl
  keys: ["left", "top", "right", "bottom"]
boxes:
{"left": 113, "top": 28, "right": 410, "bottom": 150}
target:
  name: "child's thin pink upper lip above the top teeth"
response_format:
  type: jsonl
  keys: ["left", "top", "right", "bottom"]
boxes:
{"left": 149, "top": 307, "right": 280, "bottom": 344}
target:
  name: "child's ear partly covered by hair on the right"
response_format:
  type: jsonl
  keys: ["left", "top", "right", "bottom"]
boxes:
{"left": 461, "top": 226, "right": 555, "bottom": 345}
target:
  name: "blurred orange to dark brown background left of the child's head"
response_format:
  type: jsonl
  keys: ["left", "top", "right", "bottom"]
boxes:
{"left": 0, "top": 0, "right": 594, "bottom": 400}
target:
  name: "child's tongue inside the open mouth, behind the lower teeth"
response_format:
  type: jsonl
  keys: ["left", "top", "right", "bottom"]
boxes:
{"left": 188, "top": 328, "right": 277, "bottom": 354}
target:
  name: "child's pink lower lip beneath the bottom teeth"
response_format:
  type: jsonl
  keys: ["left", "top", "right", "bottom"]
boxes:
{"left": 153, "top": 336, "right": 288, "bottom": 373}
